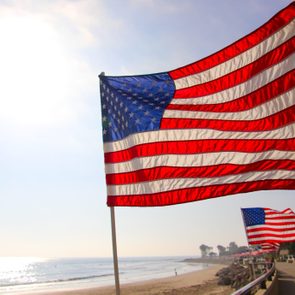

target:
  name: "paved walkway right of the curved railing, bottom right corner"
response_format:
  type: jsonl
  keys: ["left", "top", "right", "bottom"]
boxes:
{"left": 276, "top": 262, "right": 295, "bottom": 295}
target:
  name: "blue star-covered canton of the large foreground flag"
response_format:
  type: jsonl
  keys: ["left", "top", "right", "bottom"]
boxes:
{"left": 100, "top": 73, "right": 175, "bottom": 142}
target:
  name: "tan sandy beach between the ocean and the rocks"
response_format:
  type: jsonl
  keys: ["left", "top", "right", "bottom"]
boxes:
{"left": 34, "top": 264, "right": 233, "bottom": 295}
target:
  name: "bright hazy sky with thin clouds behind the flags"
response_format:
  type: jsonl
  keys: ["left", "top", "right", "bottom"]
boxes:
{"left": 0, "top": 0, "right": 295, "bottom": 257}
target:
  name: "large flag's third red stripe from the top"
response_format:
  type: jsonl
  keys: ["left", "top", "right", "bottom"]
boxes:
{"left": 167, "top": 70, "right": 295, "bottom": 112}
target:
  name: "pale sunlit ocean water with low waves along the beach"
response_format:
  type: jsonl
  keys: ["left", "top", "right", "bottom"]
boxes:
{"left": 0, "top": 256, "right": 208, "bottom": 294}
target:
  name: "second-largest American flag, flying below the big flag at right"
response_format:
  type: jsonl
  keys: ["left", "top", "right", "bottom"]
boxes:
{"left": 242, "top": 208, "right": 295, "bottom": 249}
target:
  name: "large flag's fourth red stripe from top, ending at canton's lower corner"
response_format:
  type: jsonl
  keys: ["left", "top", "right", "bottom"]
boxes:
{"left": 161, "top": 105, "right": 295, "bottom": 132}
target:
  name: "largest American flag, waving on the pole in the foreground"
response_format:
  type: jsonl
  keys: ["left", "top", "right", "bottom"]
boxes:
{"left": 100, "top": 3, "right": 295, "bottom": 206}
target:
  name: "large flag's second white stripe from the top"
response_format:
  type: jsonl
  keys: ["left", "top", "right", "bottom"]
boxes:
{"left": 171, "top": 53, "right": 295, "bottom": 105}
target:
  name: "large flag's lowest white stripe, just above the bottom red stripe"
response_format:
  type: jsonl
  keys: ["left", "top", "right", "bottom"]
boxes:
{"left": 107, "top": 170, "right": 295, "bottom": 196}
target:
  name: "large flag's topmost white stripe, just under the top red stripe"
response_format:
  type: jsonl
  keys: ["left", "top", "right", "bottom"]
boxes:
{"left": 174, "top": 20, "right": 295, "bottom": 89}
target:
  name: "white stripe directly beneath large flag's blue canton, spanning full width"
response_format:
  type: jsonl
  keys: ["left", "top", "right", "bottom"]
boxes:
{"left": 103, "top": 123, "right": 295, "bottom": 153}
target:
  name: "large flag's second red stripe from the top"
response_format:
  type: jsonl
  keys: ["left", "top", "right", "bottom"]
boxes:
{"left": 174, "top": 37, "right": 295, "bottom": 99}
